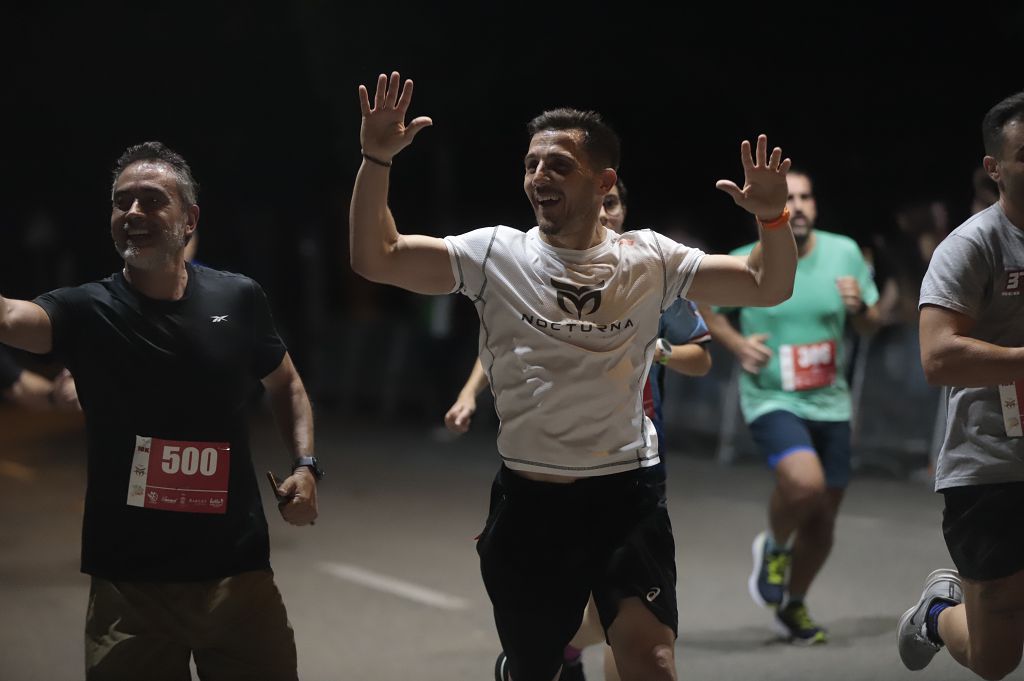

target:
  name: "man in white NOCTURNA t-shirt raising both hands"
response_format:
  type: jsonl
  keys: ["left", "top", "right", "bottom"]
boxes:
{"left": 349, "top": 73, "right": 797, "bottom": 681}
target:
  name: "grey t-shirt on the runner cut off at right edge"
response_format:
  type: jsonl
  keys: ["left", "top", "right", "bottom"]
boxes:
{"left": 921, "top": 204, "right": 1024, "bottom": 491}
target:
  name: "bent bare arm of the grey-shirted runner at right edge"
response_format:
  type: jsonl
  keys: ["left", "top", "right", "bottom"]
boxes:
{"left": 921, "top": 305, "right": 1024, "bottom": 388}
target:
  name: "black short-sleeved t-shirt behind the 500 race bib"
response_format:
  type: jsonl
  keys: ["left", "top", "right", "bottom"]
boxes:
{"left": 35, "top": 265, "right": 286, "bottom": 581}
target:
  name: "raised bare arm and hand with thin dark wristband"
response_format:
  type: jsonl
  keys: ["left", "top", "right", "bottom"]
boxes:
{"left": 348, "top": 73, "right": 455, "bottom": 294}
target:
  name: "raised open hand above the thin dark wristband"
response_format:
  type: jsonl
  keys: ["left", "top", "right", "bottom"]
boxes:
{"left": 359, "top": 71, "right": 433, "bottom": 163}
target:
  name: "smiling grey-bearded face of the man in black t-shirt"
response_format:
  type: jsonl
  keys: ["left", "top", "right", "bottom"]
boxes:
{"left": 111, "top": 161, "right": 199, "bottom": 270}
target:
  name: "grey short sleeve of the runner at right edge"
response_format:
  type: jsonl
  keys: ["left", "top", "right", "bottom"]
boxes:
{"left": 919, "top": 235, "right": 992, "bottom": 320}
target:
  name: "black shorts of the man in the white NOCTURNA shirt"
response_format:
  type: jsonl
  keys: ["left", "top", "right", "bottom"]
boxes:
{"left": 476, "top": 466, "right": 679, "bottom": 681}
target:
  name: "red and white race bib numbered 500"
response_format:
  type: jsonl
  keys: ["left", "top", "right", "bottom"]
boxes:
{"left": 128, "top": 435, "right": 231, "bottom": 513}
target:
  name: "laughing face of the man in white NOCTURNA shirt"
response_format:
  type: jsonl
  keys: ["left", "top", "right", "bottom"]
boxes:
{"left": 523, "top": 130, "right": 602, "bottom": 237}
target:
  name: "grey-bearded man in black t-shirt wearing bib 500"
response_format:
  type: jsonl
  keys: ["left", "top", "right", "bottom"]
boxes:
{"left": 0, "top": 142, "right": 321, "bottom": 680}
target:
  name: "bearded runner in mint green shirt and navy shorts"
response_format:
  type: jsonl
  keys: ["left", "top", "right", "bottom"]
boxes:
{"left": 701, "top": 170, "right": 879, "bottom": 643}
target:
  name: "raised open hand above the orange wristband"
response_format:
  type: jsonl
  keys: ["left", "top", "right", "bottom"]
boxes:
{"left": 715, "top": 135, "right": 793, "bottom": 221}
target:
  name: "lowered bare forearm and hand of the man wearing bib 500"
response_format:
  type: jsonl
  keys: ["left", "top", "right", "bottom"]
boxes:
{"left": 262, "top": 353, "right": 316, "bottom": 525}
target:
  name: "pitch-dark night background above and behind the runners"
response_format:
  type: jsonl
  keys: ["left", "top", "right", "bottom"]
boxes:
{"left": 0, "top": 0, "right": 1024, "bottom": 413}
